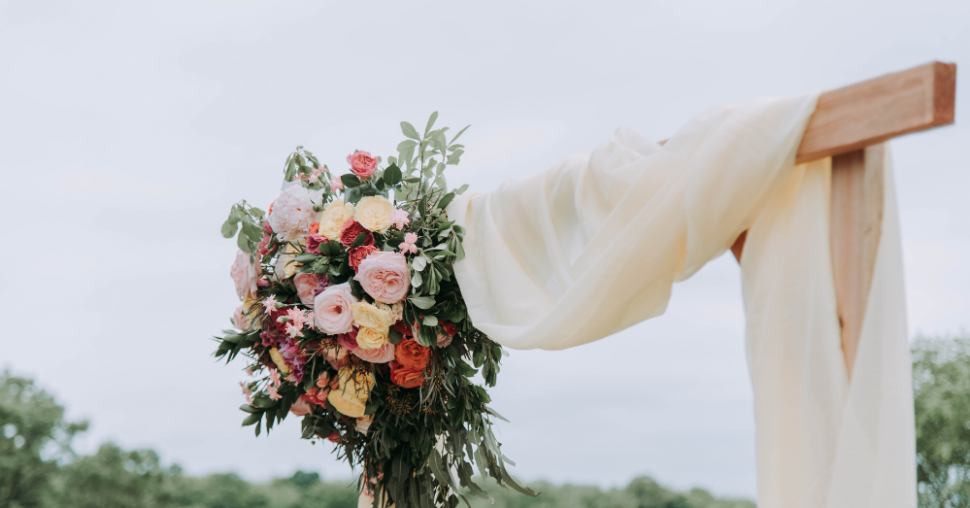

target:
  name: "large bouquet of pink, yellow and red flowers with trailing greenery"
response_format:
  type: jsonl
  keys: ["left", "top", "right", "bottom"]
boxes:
{"left": 215, "top": 113, "right": 535, "bottom": 508}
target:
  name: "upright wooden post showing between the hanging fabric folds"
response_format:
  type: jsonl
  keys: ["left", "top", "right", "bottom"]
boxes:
{"left": 830, "top": 143, "right": 885, "bottom": 379}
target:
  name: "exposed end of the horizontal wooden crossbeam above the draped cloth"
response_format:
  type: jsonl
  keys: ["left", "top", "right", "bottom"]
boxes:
{"left": 796, "top": 62, "right": 957, "bottom": 164}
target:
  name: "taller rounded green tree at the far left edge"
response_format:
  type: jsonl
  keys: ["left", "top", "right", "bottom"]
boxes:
{"left": 0, "top": 370, "right": 87, "bottom": 508}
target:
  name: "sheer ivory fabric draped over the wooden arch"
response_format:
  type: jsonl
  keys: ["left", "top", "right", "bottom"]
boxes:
{"left": 448, "top": 94, "right": 916, "bottom": 508}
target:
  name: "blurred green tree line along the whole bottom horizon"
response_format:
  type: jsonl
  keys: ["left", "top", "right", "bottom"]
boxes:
{"left": 0, "top": 335, "right": 970, "bottom": 508}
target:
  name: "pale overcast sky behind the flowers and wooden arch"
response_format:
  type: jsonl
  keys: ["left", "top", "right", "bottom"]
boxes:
{"left": 0, "top": 0, "right": 970, "bottom": 497}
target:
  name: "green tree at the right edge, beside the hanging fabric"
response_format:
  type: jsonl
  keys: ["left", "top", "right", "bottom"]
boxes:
{"left": 913, "top": 335, "right": 970, "bottom": 508}
